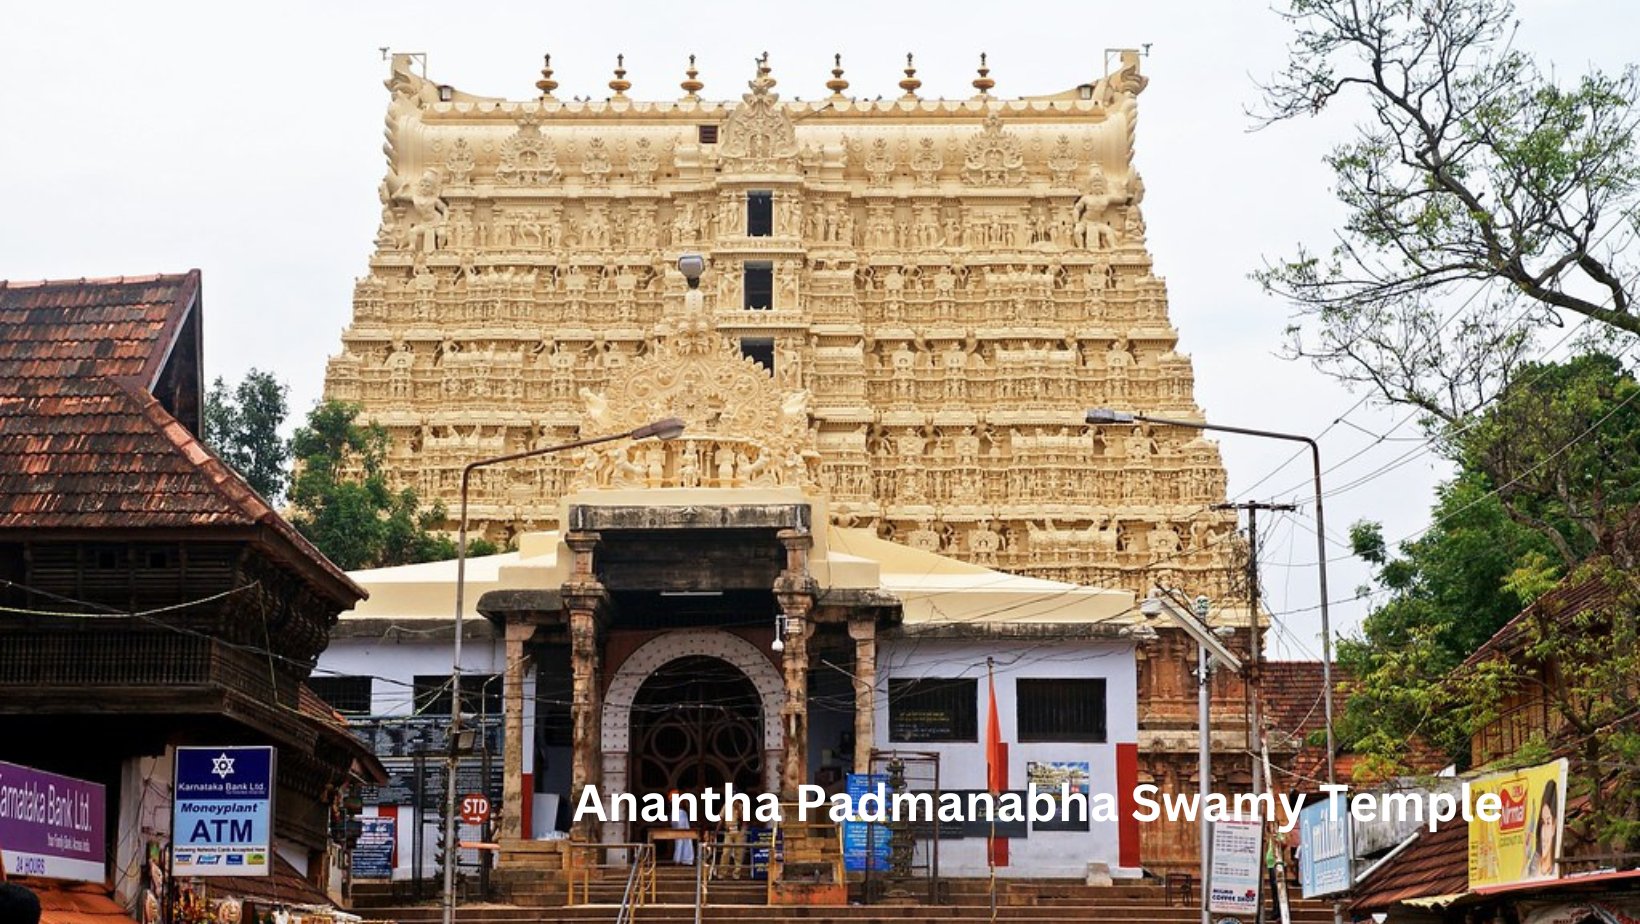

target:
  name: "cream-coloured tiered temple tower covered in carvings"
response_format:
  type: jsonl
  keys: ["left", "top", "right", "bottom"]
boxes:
{"left": 326, "top": 54, "right": 1235, "bottom": 596}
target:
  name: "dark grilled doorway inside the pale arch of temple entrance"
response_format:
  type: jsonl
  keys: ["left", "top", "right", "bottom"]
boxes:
{"left": 628, "top": 655, "right": 763, "bottom": 793}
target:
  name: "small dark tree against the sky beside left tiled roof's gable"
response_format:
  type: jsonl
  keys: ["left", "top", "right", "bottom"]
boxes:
{"left": 203, "top": 369, "right": 290, "bottom": 502}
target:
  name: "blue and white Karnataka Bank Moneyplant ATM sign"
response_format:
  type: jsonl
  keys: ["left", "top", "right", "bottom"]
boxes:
{"left": 171, "top": 747, "right": 274, "bottom": 876}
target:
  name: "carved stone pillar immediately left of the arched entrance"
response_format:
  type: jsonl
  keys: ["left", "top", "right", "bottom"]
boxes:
{"left": 563, "top": 532, "right": 607, "bottom": 840}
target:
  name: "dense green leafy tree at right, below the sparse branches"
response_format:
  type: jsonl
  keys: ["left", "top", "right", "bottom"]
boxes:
{"left": 1338, "top": 355, "right": 1640, "bottom": 771}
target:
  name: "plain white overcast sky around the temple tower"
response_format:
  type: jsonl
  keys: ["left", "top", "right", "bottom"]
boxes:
{"left": 0, "top": 0, "right": 1640, "bottom": 658}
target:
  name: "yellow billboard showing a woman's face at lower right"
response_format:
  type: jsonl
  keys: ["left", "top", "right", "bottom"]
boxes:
{"left": 1469, "top": 760, "right": 1566, "bottom": 890}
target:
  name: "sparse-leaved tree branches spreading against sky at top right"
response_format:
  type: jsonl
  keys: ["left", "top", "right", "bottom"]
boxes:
{"left": 1255, "top": 0, "right": 1640, "bottom": 423}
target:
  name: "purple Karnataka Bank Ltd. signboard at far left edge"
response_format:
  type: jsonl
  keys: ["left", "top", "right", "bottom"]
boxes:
{"left": 0, "top": 762, "right": 108, "bottom": 883}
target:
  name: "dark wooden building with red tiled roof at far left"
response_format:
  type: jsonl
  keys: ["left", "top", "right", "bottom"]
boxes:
{"left": 0, "top": 271, "right": 379, "bottom": 908}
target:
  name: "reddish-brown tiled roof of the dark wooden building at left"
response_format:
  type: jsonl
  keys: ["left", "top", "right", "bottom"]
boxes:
{"left": 0, "top": 271, "right": 364, "bottom": 604}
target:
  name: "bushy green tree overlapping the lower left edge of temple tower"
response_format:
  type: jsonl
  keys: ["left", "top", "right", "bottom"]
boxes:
{"left": 290, "top": 400, "right": 456, "bottom": 571}
